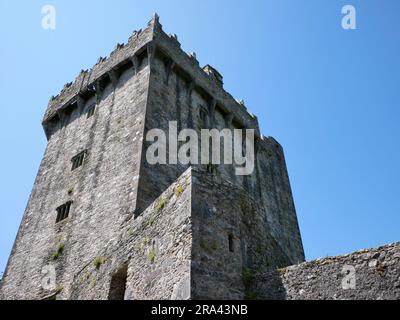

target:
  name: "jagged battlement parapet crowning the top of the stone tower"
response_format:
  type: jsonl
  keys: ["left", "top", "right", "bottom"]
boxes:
{"left": 43, "top": 14, "right": 260, "bottom": 138}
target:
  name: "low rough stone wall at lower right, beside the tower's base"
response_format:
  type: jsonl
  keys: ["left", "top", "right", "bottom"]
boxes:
{"left": 254, "top": 243, "right": 400, "bottom": 300}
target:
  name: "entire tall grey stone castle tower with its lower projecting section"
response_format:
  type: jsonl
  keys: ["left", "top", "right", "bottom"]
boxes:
{"left": 1, "top": 15, "right": 304, "bottom": 299}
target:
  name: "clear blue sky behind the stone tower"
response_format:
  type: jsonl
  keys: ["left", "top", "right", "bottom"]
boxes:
{"left": 0, "top": 0, "right": 400, "bottom": 276}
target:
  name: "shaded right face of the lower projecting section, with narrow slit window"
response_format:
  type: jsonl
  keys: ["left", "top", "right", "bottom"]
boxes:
{"left": 192, "top": 166, "right": 291, "bottom": 299}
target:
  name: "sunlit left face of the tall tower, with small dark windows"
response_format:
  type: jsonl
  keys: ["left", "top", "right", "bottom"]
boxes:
{"left": 2, "top": 46, "right": 149, "bottom": 299}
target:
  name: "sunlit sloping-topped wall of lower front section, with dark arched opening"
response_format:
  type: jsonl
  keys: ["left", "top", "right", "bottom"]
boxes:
{"left": 64, "top": 169, "right": 192, "bottom": 300}
